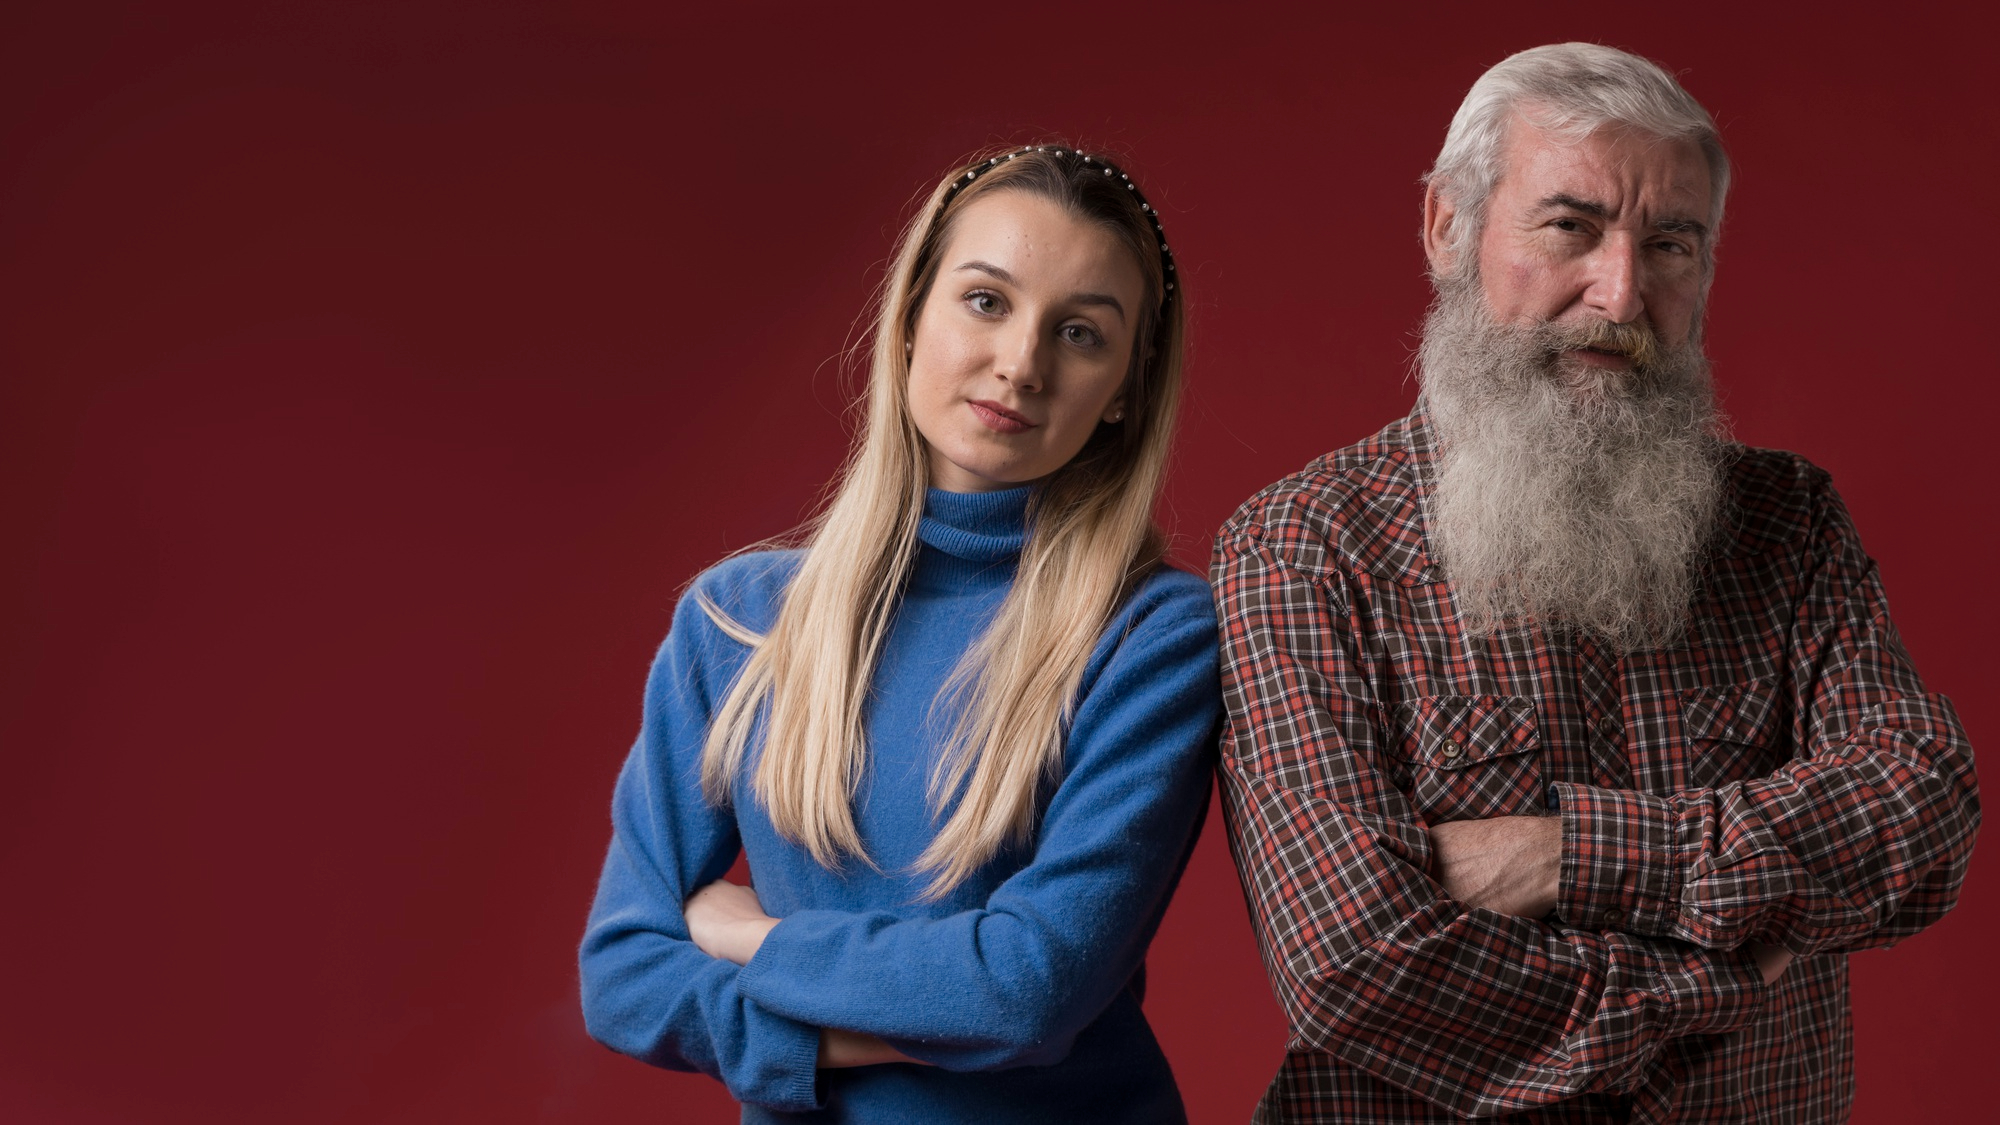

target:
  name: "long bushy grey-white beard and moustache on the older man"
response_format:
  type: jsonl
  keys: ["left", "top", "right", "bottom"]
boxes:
{"left": 1418, "top": 280, "right": 1726, "bottom": 653}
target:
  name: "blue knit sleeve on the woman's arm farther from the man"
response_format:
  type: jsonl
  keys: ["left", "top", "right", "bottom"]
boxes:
{"left": 578, "top": 556, "right": 820, "bottom": 1111}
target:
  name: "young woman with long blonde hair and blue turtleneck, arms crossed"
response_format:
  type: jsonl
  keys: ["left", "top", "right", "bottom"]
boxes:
{"left": 582, "top": 146, "right": 1220, "bottom": 1123}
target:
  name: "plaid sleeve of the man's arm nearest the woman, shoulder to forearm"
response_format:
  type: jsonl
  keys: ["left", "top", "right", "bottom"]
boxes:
{"left": 1214, "top": 526, "right": 1764, "bottom": 1117}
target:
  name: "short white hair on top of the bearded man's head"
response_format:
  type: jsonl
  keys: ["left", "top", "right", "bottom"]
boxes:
{"left": 1424, "top": 42, "right": 1730, "bottom": 260}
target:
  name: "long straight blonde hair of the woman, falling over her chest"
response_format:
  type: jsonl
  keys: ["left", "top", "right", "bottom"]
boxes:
{"left": 702, "top": 144, "right": 1184, "bottom": 899}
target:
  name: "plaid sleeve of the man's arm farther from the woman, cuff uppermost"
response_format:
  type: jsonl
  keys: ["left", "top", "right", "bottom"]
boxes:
{"left": 1556, "top": 476, "right": 1980, "bottom": 955}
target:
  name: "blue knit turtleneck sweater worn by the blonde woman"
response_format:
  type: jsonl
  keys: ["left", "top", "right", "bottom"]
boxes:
{"left": 582, "top": 488, "right": 1220, "bottom": 1123}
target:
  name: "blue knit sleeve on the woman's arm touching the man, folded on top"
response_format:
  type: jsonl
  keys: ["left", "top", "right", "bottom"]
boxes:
{"left": 738, "top": 571, "right": 1222, "bottom": 1071}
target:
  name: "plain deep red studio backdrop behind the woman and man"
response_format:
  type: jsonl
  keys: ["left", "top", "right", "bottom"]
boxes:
{"left": 0, "top": 0, "right": 2000, "bottom": 1125}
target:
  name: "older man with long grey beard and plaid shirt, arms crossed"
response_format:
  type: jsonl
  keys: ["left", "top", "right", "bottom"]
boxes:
{"left": 1214, "top": 44, "right": 1978, "bottom": 1125}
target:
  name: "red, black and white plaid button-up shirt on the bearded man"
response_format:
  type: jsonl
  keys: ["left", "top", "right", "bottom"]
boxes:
{"left": 1212, "top": 404, "right": 1978, "bottom": 1125}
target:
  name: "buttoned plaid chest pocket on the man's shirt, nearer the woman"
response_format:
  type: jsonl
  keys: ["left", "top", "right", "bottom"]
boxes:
{"left": 1402, "top": 695, "right": 1542, "bottom": 825}
